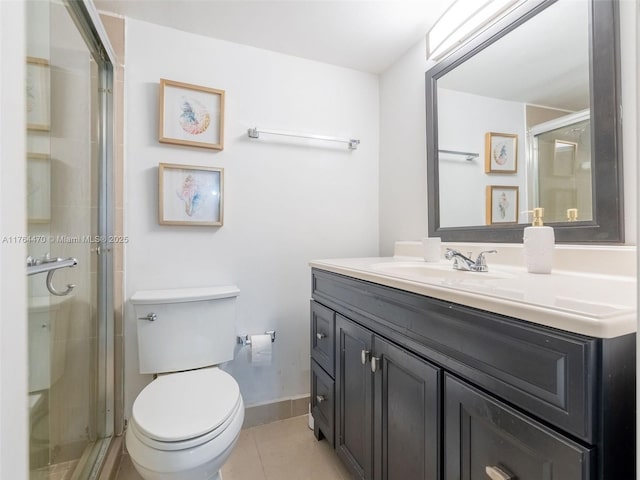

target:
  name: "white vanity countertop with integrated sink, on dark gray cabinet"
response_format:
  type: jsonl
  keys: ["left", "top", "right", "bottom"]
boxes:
{"left": 309, "top": 257, "right": 637, "bottom": 338}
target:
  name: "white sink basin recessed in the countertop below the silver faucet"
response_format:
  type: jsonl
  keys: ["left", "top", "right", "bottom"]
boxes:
{"left": 371, "top": 262, "right": 514, "bottom": 283}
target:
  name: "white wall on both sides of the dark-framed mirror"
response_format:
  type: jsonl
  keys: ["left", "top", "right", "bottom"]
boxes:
{"left": 380, "top": 4, "right": 638, "bottom": 248}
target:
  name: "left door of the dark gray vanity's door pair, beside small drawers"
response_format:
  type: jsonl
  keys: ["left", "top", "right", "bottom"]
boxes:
{"left": 335, "top": 315, "right": 373, "bottom": 480}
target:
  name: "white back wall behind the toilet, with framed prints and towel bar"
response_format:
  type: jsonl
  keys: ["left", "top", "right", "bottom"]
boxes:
{"left": 125, "top": 19, "right": 379, "bottom": 415}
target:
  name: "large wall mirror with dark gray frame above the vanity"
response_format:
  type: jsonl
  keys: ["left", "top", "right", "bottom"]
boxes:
{"left": 426, "top": 0, "right": 624, "bottom": 243}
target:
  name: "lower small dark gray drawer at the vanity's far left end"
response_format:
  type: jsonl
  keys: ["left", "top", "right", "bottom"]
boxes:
{"left": 311, "top": 360, "right": 335, "bottom": 446}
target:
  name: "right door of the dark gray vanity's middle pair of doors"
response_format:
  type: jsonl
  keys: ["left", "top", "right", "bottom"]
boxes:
{"left": 372, "top": 337, "right": 441, "bottom": 480}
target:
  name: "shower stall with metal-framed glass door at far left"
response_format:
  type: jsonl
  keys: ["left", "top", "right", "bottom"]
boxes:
{"left": 26, "top": 0, "right": 114, "bottom": 480}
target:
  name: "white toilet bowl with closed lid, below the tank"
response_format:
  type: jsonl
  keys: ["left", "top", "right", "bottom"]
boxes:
{"left": 126, "top": 367, "right": 244, "bottom": 480}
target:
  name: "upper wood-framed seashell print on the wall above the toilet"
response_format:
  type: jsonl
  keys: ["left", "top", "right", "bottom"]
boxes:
{"left": 158, "top": 78, "right": 224, "bottom": 150}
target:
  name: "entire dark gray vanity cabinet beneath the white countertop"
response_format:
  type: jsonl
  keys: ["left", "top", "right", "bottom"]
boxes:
{"left": 311, "top": 269, "right": 635, "bottom": 480}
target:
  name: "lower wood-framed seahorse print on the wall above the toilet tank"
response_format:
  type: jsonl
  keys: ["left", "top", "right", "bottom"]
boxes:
{"left": 158, "top": 163, "right": 224, "bottom": 227}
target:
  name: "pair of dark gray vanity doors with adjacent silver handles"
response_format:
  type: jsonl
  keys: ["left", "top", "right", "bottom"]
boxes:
{"left": 335, "top": 314, "right": 440, "bottom": 480}
